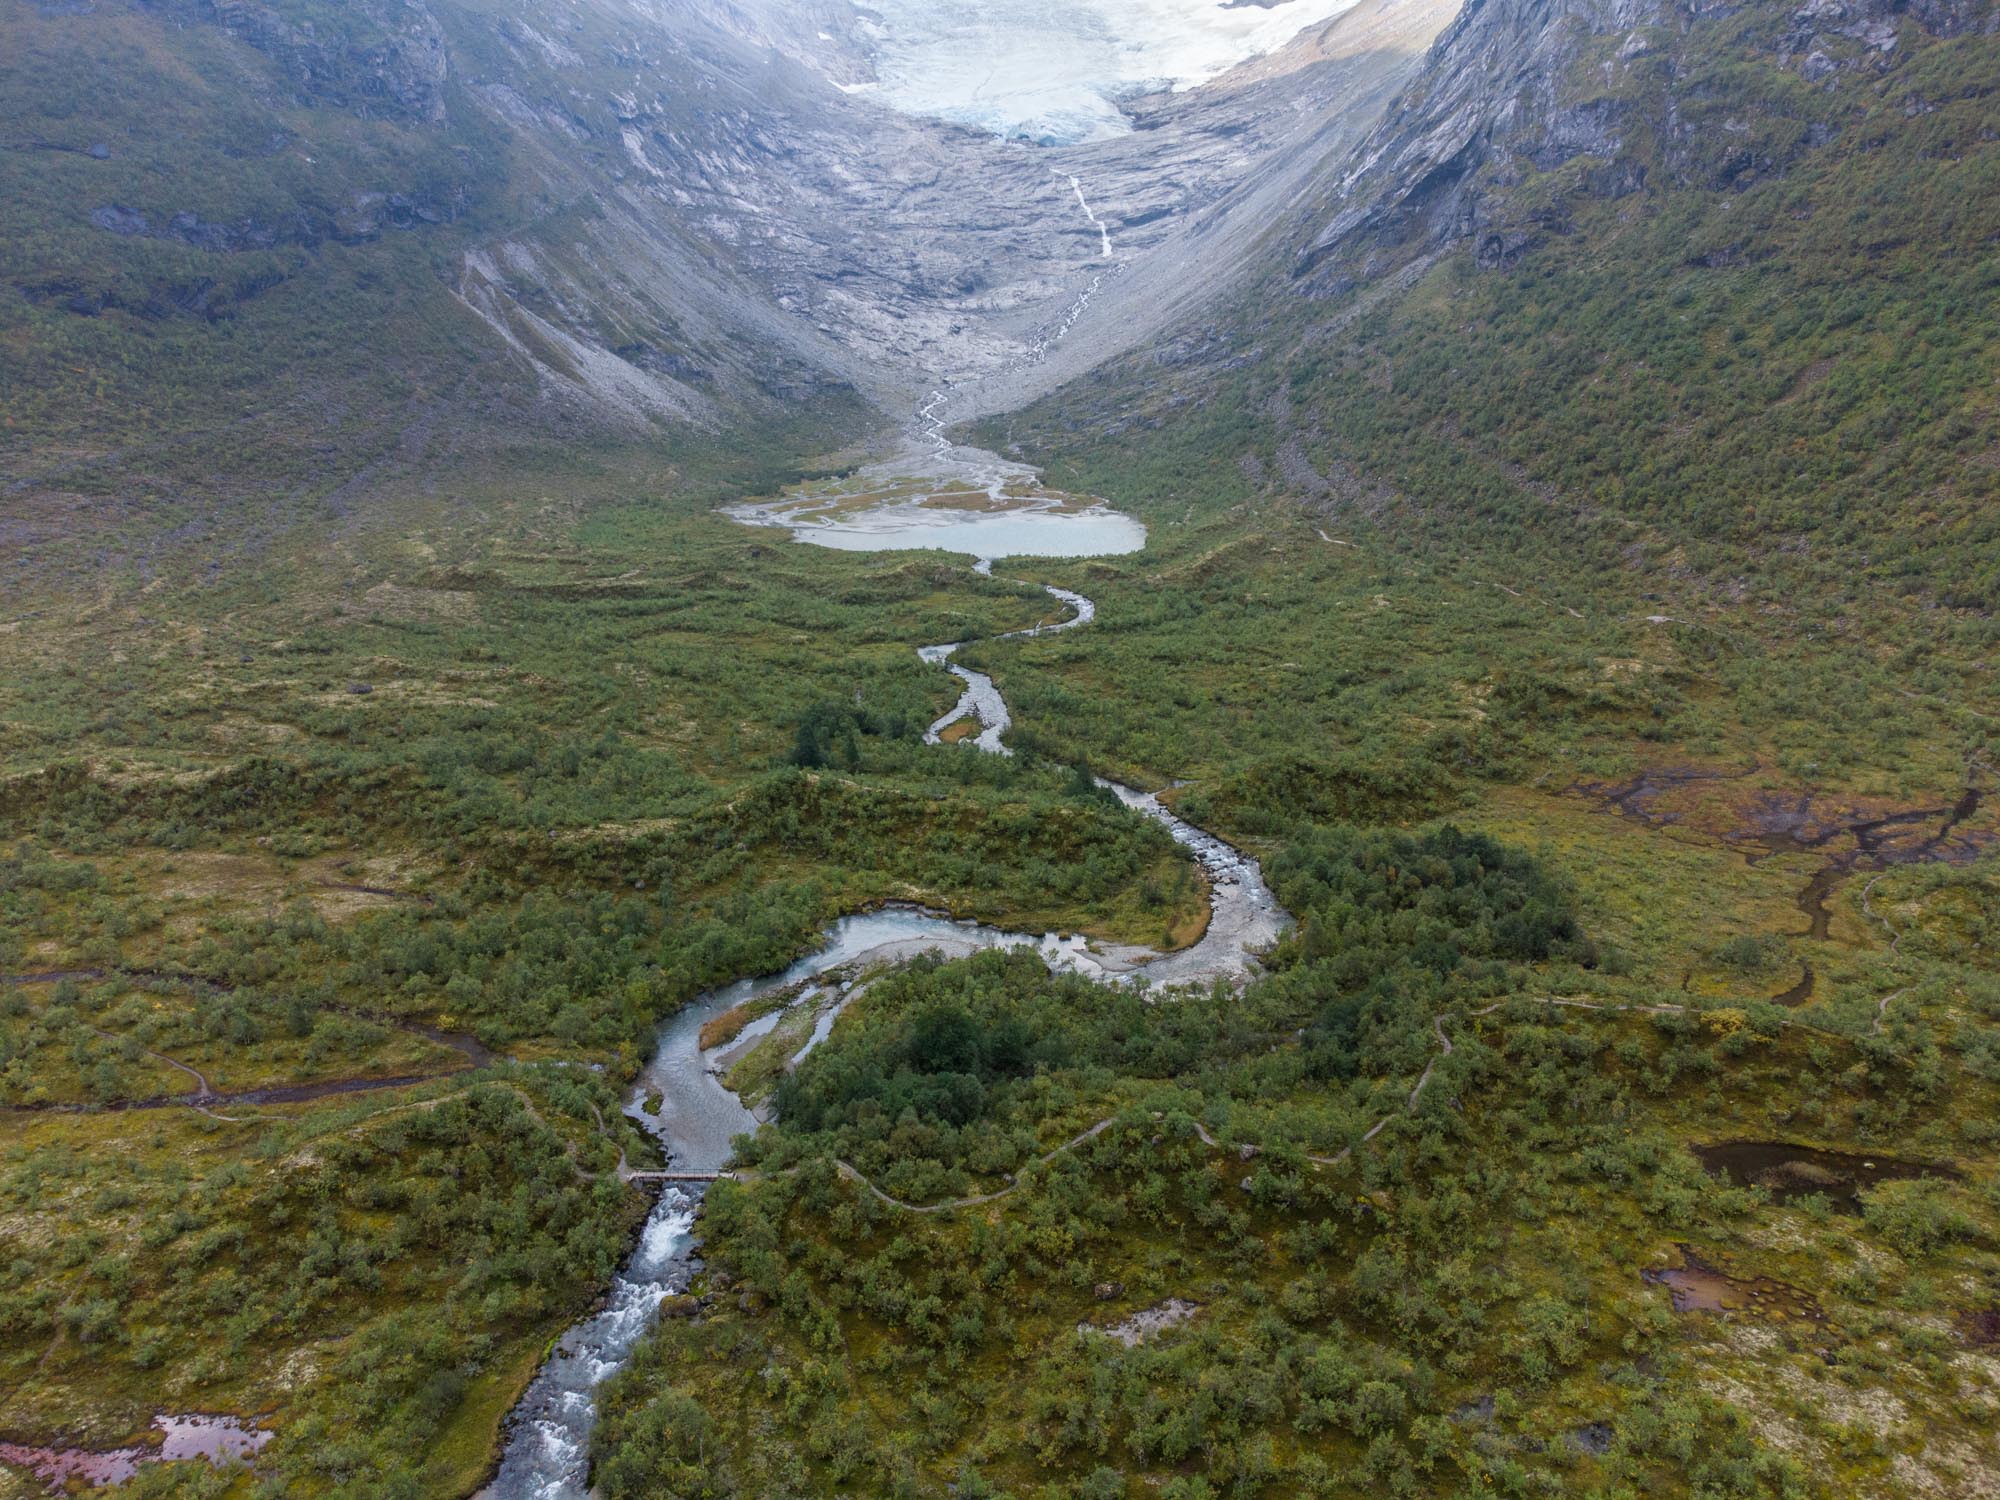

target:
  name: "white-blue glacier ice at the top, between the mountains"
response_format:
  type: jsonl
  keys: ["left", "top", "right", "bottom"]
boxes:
{"left": 836, "top": 0, "right": 1354, "bottom": 144}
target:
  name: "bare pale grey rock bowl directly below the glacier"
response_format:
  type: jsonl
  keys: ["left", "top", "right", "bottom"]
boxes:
{"left": 430, "top": 0, "right": 1446, "bottom": 440}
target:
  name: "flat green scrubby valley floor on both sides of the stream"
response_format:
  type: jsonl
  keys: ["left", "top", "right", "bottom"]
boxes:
{"left": 0, "top": 438, "right": 2000, "bottom": 1496}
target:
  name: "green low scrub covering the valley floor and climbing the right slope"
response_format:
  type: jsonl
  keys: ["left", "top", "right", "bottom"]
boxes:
{"left": 0, "top": 6, "right": 2000, "bottom": 1500}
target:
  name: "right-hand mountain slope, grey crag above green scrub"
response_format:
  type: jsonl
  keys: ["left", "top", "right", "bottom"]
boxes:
{"left": 1012, "top": 0, "right": 2000, "bottom": 614}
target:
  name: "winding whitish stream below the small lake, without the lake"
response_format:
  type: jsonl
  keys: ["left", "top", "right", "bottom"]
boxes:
{"left": 480, "top": 558, "right": 1290, "bottom": 1500}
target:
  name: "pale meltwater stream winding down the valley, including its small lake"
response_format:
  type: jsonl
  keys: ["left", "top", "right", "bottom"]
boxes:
{"left": 480, "top": 458, "right": 1290, "bottom": 1500}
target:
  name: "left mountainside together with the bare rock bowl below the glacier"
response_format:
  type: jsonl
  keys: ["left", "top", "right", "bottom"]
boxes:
{"left": 0, "top": 0, "right": 1448, "bottom": 576}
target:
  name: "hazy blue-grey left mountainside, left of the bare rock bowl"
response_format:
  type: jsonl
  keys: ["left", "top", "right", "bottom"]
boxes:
{"left": 0, "top": 0, "right": 892, "bottom": 470}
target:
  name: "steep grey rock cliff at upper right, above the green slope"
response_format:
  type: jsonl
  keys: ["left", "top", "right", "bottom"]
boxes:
{"left": 1296, "top": 0, "right": 1994, "bottom": 290}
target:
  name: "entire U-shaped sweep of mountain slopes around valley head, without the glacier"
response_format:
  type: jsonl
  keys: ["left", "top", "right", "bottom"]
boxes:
{"left": 11, "top": 0, "right": 2000, "bottom": 600}
